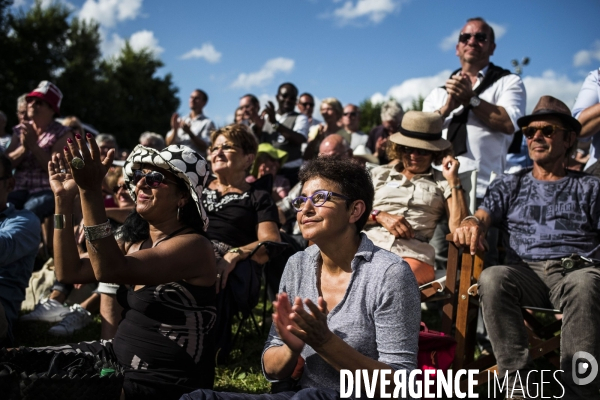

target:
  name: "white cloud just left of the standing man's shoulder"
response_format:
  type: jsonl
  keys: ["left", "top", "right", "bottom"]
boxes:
{"left": 371, "top": 70, "right": 452, "bottom": 108}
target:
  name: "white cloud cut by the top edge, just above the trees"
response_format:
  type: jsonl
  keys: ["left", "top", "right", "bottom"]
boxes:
{"left": 79, "top": 0, "right": 142, "bottom": 28}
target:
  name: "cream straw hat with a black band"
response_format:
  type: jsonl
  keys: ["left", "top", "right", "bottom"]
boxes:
{"left": 390, "top": 111, "right": 451, "bottom": 151}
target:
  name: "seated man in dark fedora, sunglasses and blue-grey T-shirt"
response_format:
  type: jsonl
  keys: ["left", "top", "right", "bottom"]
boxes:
{"left": 454, "top": 96, "right": 600, "bottom": 399}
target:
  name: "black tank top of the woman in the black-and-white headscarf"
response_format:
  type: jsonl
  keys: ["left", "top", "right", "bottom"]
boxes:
{"left": 113, "top": 232, "right": 217, "bottom": 398}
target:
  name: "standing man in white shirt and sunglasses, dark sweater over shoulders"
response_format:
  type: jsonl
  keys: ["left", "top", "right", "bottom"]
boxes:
{"left": 423, "top": 18, "right": 526, "bottom": 200}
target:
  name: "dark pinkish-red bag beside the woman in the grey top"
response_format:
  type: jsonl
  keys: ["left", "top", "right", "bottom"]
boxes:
{"left": 417, "top": 322, "right": 456, "bottom": 370}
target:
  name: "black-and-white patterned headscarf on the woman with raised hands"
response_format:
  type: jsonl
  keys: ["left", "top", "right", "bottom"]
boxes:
{"left": 123, "top": 144, "right": 209, "bottom": 231}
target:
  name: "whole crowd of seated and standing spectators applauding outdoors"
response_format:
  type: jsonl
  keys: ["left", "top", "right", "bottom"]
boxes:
{"left": 0, "top": 18, "right": 600, "bottom": 400}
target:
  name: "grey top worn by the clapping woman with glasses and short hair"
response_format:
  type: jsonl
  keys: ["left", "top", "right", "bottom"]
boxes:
{"left": 263, "top": 233, "right": 421, "bottom": 391}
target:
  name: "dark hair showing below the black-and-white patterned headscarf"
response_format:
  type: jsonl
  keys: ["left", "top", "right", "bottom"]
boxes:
{"left": 119, "top": 178, "right": 206, "bottom": 243}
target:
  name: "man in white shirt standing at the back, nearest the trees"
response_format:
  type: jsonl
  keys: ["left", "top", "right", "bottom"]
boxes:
{"left": 166, "top": 89, "right": 216, "bottom": 156}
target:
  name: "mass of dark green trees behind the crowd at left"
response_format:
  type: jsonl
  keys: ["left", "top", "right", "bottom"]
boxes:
{"left": 0, "top": 0, "right": 179, "bottom": 147}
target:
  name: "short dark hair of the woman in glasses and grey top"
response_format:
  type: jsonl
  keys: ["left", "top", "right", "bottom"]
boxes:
{"left": 299, "top": 157, "right": 375, "bottom": 233}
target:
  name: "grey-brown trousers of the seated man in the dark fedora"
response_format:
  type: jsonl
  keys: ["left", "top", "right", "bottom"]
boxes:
{"left": 479, "top": 260, "right": 600, "bottom": 399}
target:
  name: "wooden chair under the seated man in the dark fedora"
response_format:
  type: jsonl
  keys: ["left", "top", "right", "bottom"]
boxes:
{"left": 442, "top": 234, "right": 561, "bottom": 389}
